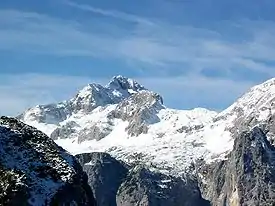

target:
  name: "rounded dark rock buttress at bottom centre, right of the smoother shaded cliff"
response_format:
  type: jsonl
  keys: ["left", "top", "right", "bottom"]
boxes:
{"left": 117, "top": 166, "right": 209, "bottom": 206}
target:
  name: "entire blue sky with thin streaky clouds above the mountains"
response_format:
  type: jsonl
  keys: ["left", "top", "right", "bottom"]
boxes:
{"left": 0, "top": 0, "right": 275, "bottom": 115}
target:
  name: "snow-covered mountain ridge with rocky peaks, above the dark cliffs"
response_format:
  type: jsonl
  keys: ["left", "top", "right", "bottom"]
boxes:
{"left": 19, "top": 76, "right": 275, "bottom": 175}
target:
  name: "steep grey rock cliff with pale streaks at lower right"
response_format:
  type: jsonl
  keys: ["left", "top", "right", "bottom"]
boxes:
{"left": 199, "top": 127, "right": 275, "bottom": 206}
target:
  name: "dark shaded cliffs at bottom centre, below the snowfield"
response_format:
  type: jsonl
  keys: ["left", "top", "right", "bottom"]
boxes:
{"left": 76, "top": 153, "right": 209, "bottom": 206}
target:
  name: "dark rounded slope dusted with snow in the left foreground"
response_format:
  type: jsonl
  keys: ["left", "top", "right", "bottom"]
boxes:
{"left": 0, "top": 117, "right": 95, "bottom": 206}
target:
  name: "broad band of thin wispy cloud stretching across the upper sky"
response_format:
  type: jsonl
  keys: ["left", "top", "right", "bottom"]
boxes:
{"left": 0, "top": 6, "right": 275, "bottom": 78}
